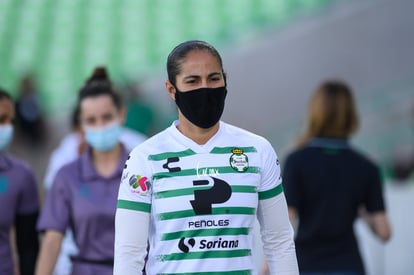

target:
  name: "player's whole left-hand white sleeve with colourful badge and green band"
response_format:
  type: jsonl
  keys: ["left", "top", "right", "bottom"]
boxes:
{"left": 114, "top": 149, "right": 152, "bottom": 275}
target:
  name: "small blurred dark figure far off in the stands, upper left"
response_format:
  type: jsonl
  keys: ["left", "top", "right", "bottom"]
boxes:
{"left": 16, "top": 74, "right": 47, "bottom": 145}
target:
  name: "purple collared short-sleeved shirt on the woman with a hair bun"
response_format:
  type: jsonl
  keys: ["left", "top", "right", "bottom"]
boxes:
{"left": 38, "top": 148, "right": 128, "bottom": 266}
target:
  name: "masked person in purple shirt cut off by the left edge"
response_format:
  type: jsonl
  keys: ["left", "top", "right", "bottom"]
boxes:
{"left": 0, "top": 89, "right": 39, "bottom": 275}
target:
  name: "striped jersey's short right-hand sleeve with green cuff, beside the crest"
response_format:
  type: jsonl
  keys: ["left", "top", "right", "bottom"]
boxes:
{"left": 258, "top": 142, "right": 283, "bottom": 200}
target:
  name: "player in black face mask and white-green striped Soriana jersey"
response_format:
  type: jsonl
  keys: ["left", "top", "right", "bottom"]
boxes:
{"left": 114, "top": 40, "right": 298, "bottom": 275}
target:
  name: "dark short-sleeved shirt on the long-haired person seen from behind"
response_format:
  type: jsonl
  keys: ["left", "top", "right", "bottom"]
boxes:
{"left": 282, "top": 139, "right": 385, "bottom": 273}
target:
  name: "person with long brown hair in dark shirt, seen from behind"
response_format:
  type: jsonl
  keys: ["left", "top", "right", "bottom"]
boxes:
{"left": 282, "top": 80, "right": 391, "bottom": 275}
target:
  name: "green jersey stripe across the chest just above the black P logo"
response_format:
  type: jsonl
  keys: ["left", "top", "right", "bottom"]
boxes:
{"left": 152, "top": 166, "right": 260, "bottom": 179}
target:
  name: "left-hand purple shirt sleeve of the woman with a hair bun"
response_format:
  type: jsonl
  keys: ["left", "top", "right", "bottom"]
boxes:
{"left": 37, "top": 168, "right": 71, "bottom": 232}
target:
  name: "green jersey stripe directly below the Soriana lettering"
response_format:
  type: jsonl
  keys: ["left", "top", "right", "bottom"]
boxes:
{"left": 158, "top": 249, "right": 251, "bottom": 261}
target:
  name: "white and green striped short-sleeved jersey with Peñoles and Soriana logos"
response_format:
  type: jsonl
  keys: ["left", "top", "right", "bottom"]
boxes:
{"left": 118, "top": 121, "right": 283, "bottom": 274}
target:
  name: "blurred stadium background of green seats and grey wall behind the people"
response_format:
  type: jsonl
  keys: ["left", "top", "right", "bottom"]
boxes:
{"left": 0, "top": 0, "right": 414, "bottom": 275}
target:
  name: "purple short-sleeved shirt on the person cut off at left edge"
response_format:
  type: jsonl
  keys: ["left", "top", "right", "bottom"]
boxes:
{"left": 0, "top": 154, "right": 39, "bottom": 275}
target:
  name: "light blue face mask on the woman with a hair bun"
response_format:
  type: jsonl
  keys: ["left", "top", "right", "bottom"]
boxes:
{"left": 84, "top": 122, "right": 122, "bottom": 152}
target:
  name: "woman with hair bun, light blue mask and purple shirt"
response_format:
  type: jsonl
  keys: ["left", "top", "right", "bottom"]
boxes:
{"left": 36, "top": 68, "right": 129, "bottom": 275}
